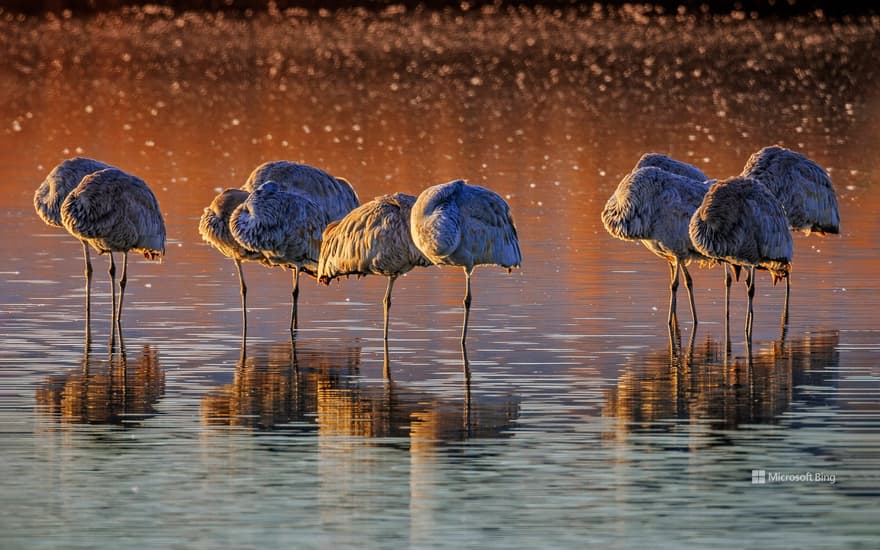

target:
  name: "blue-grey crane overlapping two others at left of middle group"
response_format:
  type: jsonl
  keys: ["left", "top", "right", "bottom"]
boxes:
{"left": 229, "top": 181, "right": 330, "bottom": 331}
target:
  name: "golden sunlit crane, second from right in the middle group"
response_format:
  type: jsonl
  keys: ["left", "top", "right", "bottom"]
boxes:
{"left": 318, "top": 193, "right": 431, "bottom": 341}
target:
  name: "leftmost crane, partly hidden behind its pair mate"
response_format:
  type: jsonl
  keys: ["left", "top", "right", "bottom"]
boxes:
{"left": 34, "top": 157, "right": 112, "bottom": 319}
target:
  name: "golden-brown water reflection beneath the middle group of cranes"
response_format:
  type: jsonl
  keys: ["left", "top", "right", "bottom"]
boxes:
{"left": 202, "top": 341, "right": 518, "bottom": 441}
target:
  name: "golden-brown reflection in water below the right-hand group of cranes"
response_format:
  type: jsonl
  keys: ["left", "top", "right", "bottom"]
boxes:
{"left": 603, "top": 332, "right": 839, "bottom": 438}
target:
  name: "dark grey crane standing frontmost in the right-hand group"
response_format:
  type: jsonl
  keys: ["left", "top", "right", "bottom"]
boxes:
{"left": 688, "top": 177, "right": 792, "bottom": 340}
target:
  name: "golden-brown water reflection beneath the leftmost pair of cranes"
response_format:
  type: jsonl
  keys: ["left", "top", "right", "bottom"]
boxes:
{"left": 36, "top": 340, "right": 165, "bottom": 426}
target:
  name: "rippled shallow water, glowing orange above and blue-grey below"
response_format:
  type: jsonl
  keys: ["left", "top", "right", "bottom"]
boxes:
{"left": 0, "top": 9, "right": 880, "bottom": 548}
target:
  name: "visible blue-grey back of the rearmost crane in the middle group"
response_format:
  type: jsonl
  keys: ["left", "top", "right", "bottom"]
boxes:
{"left": 242, "top": 160, "right": 360, "bottom": 221}
